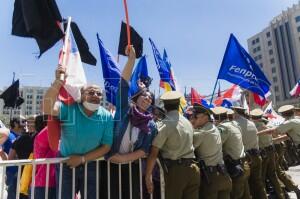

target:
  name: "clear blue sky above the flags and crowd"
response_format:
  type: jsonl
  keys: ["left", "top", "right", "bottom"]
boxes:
{"left": 0, "top": 0, "right": 298, "bottom": 95}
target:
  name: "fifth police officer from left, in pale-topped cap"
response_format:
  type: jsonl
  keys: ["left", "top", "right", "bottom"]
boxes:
{"left": 250, "top": 109, "right": 285, "bottom": 199}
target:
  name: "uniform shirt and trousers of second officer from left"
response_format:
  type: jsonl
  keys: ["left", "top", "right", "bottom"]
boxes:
{"left": 194, "top": 122, "right": 232, "bottom": 199}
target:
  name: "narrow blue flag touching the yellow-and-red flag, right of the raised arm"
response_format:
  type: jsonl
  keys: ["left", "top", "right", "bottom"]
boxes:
{"left": 149, "top": 38, "right": 176, "bottom": 90}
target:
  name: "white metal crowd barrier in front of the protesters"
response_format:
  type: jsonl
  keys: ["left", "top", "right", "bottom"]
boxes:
{"left": 0, "top": 158, "right": 165, "bottom": 199}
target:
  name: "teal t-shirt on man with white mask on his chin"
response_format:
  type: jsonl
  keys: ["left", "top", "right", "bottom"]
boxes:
{"left": 58, "top": 103, "right": 113, "bottom": 157}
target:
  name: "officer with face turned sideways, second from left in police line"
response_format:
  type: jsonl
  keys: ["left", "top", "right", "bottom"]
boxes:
{"left": 190, "top": 104, "right": 232, "bottom": 199}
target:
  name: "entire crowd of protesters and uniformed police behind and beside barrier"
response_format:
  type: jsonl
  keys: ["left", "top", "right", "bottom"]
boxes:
{"left": 0, "top": 47, "right": 300, "bottom": 199}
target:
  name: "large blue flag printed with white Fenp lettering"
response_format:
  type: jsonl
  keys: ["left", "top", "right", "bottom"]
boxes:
{"left": 218, "top": 34, "right": 271, "bottom": 97}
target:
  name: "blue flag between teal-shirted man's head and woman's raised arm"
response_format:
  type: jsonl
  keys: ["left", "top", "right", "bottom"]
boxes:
{"left": 97, "top": 34, "right": 121, "bottom": 105}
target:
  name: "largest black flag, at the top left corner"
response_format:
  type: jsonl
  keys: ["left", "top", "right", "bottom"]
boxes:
{"left": 12, "top": 0, "right": 64, "bottom": 56}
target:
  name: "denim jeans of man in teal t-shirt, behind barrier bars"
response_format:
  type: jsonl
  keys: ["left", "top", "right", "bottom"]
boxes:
{"left": 56, "top": 162, "right": 96, "bottom": 199}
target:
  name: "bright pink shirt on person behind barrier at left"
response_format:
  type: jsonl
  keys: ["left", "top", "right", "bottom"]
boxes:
{"left": 33, "top": 127, "right": 56, "bottom": 187}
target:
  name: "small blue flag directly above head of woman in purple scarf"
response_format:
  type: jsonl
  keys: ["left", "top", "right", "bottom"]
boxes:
{"left": 130, "top": 55, "right": 151, "bottom": 96}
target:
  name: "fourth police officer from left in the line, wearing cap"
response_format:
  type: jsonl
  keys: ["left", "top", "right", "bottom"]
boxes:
{"left": 233, "top": 107, "right": 267, "bottom": 199}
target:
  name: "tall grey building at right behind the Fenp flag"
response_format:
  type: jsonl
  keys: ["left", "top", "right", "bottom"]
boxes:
{"left": 247, "top": 3, "right": 300, "bottom": 107}
